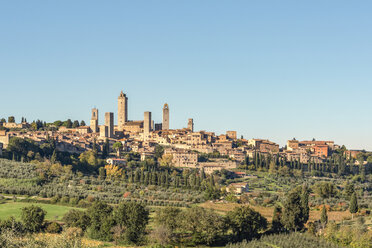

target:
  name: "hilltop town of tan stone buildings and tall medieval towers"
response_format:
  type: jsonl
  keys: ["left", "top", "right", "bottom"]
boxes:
{"left": 0, "top": 91, "right": 367, "bottom": 173}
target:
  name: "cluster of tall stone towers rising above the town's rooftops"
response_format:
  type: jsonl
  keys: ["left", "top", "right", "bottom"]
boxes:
{"left": 90, "top": 91, "right": 172, "bottom": 139}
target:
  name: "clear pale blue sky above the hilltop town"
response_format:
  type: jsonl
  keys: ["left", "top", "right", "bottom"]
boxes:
{"left": 0, "top": 0, "right": 372, "bottom": 150}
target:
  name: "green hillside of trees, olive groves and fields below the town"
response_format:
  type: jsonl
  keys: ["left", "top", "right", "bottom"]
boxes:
{"left": 0, "top": 140, "right": 372, "bottom": 247}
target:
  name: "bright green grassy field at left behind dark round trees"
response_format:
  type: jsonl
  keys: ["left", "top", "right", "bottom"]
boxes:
{"left": 0, "top": 202, "right": 83, "bottom": 220}
